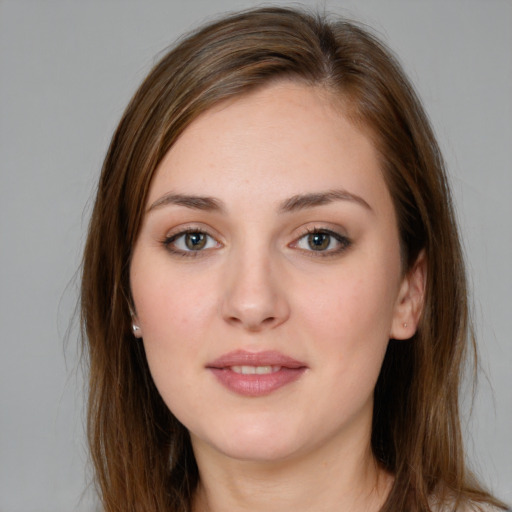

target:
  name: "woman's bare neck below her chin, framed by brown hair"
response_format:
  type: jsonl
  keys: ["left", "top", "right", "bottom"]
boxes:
{"left": 192, "top": 424, "right": 393, "bottom": 512}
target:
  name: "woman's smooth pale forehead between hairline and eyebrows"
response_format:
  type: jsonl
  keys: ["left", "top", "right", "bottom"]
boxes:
{"left": 148, "top": 82, "right": 389, "bottom": 216}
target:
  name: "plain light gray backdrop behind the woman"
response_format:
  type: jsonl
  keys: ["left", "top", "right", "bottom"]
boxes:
{"left": 0, "top": 0, "right": 512, "bottom": 512}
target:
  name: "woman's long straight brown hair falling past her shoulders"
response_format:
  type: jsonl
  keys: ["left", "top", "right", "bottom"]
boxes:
{"left": 81, "top": 8, "right": 506, "bottom": 512}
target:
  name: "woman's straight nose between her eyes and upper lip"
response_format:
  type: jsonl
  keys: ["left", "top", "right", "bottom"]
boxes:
{"left": 222, "top": 248, "right": 290, "bottom": 332}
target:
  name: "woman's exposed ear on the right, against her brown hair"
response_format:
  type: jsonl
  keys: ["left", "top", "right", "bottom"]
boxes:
{"left": 390, "top": 251, "right": 427, "bottom": 340}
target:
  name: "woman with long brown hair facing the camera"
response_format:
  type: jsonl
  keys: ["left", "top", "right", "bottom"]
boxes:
{"left": 82, "top": 8, "right": 508, "bottom": 511}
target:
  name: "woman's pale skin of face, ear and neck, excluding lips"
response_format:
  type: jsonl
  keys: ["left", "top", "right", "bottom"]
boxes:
{"left": 130, "top": 82, "right": 425, "bottom": 512}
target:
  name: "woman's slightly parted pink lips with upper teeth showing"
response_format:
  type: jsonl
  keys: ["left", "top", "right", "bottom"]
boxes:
{"left": 206, "top": 350, "right": 307, "bottom": 397}
